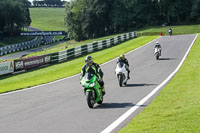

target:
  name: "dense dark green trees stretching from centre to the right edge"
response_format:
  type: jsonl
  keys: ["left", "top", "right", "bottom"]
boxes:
{"left": 65, "top": 0, "right": 200, "bottom": 41}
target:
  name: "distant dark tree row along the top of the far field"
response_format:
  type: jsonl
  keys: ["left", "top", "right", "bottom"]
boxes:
{"left": 33, "top": 0, "right": 65, "bottom": 7}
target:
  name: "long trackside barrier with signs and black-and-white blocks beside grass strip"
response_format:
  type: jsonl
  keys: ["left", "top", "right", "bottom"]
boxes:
{"left": 0, "top": 32, "right": 137, "bottom": 75}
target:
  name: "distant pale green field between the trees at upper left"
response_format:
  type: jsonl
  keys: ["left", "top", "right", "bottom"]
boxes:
{"left": 30, "top": 7, "right": 66, "bottom": 31}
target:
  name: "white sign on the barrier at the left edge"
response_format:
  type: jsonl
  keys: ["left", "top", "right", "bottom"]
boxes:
{"left": 0, "top": 61, "right": 14, "bottom": 75}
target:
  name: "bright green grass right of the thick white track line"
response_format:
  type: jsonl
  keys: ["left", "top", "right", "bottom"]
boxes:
{"left": 119, "top": 36, "right": 200, "bottom": 133}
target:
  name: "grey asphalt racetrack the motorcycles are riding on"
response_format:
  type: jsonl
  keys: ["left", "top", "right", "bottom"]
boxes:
{"left": 0, "top": 35, "right": 195, "bottom": 133}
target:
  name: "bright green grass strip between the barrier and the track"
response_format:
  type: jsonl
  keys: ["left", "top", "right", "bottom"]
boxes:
{"left": 0, "top": 36, "right": 157, "bottom": 93}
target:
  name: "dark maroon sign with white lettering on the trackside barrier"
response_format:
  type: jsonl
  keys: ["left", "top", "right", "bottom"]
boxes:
{"left": 14, "top": 55, "right": 51, "bottom": 71}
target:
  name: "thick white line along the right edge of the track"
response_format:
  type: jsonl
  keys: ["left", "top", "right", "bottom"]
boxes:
{"left": 101, "top": 34, "right": 198, "bottom": 133}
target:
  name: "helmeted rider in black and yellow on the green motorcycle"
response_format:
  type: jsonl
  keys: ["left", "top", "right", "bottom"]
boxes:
{"left": 81, "top": 55, "right": 105, "bottom": 95}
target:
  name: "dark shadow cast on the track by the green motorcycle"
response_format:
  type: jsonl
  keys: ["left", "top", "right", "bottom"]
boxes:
{"left": 94, "top": 103, "right": 147, "bottom": 109}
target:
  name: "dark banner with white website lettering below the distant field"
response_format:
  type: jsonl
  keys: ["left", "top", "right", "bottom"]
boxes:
{"left": 20, "top": 31, "right": 66, "bottom": 36}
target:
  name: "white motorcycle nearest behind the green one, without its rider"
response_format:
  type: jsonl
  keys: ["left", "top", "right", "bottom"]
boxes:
{"left": 115, "top": 62, "right": 128, "bottom": 87}
